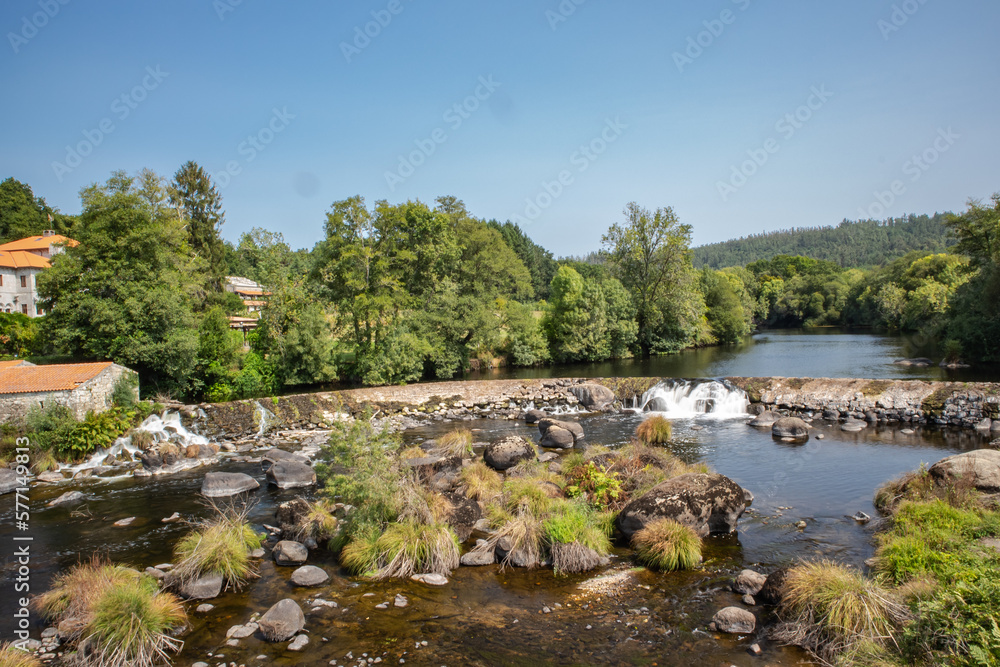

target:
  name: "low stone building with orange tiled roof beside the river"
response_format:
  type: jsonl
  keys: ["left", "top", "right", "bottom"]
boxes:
{"left": 0, "top": 360, "right": 139, "bottom": 422}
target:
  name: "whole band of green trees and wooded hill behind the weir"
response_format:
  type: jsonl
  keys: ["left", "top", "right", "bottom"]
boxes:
{"left": 0, "top": 170, "right": 1000, "bottom": 401}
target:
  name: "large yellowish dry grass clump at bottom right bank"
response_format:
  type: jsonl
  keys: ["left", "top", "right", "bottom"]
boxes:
{"left": 773, "top": 561, "right": 908, "bottom": 661}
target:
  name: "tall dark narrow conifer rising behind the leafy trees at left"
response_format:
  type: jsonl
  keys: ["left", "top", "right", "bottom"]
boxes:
{"left": 168, "top": 161, "right": 227, "bottom": 291}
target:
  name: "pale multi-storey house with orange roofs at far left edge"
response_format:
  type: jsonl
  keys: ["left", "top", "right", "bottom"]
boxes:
{"left": 0, "top": 231, "right": 77, "bottom": 317}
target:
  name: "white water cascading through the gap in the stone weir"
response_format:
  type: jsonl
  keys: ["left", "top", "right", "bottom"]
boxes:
{"left": 635, "top": 380, "right": 750, "bottom": 417}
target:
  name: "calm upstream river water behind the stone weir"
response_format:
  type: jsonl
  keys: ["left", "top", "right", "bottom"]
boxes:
{"left": 467, "top": 327, "right": 1000, "bottom": 382}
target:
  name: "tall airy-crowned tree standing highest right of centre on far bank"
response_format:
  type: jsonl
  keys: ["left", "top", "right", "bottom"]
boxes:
{"left": 601, "top": 202, "right": 704, "bottom": 356}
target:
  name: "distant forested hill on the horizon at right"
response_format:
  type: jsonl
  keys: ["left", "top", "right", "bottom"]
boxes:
{"left": 692, "top": 213, "right": 954, "bottom": 269}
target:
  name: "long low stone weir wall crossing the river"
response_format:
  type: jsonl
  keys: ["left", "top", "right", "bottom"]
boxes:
{"left": 185, "top": 377, "right": 1000, "bottom": 437}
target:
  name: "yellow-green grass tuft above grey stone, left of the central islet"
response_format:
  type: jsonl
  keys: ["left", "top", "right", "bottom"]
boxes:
{"left": 172, "top": 512, "right": 261, "bottom": 590}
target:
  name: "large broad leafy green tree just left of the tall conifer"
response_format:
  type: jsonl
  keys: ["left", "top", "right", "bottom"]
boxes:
{"left": 38, "top": 170, "right": 207, "bottom": 396}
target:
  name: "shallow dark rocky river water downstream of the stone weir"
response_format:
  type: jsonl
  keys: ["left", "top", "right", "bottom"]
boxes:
{"left": 0, "top": 414, "right": 984, "bottom": 667}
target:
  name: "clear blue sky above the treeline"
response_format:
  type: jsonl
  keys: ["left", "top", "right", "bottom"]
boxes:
{"left": 0, "top": 0, "right": 1000, "bottom": 256}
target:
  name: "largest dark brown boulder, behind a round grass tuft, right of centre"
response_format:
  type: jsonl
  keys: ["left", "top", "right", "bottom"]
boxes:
{"left": 615, "top": 473, "right": 747, "bottom": 539}
